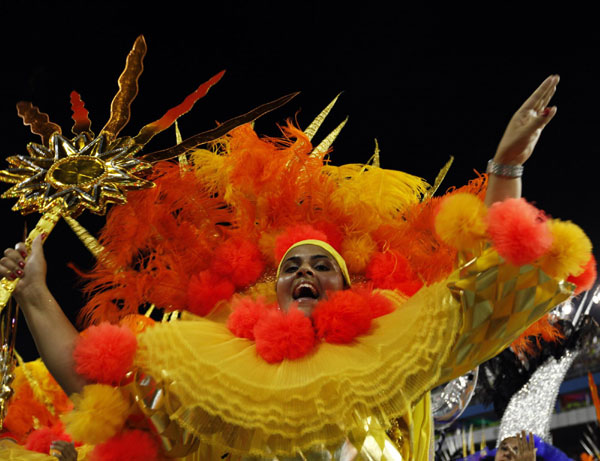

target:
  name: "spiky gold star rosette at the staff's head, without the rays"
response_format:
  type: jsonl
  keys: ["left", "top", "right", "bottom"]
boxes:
{"left": 2, "top": 129, "right": 153, "bottom": 216}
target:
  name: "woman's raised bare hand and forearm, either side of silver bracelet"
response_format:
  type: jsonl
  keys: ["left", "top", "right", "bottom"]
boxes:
{"left": 485, "top": 75, "right": 559, "bottom": 206}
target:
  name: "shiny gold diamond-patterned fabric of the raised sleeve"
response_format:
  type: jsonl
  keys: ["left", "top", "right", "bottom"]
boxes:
{"left": 439, "top": 248, "right": 574, "bottom": 384}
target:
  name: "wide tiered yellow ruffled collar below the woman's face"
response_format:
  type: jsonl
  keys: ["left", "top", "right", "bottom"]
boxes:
{"left": 136, "top": 281, "right": 461, "bottom": 456}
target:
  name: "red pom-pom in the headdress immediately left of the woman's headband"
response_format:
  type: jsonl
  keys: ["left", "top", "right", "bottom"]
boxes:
{"left": 212, "top": 238, "right": 265, "bottom": 288}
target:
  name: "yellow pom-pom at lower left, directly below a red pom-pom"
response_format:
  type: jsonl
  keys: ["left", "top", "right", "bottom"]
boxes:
{"left": 61, "top": 384, "right": 130, "bottom": 445}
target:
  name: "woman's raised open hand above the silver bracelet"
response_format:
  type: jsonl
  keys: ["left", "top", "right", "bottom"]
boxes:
{"left": 494, "top": 75, "right": 559, "bottom": 165}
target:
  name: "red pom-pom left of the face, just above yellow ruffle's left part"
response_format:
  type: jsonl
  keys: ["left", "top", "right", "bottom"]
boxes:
{"left": 187, "top": 271, "right": 235, "bottom": 316}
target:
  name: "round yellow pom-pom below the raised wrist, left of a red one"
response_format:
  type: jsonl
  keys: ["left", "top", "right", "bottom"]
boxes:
{"left": 435, "top": 193, "right": 487, "bottom": 250}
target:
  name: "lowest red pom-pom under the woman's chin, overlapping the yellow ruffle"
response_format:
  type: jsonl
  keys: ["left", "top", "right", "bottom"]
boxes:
{"left": 254, "top": 308, "right": 315, "bottom": 363}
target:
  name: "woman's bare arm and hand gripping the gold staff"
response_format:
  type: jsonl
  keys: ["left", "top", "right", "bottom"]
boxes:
{"left": 0, "top": 237, "right": 86, "bottom": 394}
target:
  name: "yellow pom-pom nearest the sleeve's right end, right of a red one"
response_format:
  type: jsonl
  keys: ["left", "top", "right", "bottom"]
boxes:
{"left": 539, "top": 219, "right": 592, "bottom": 279}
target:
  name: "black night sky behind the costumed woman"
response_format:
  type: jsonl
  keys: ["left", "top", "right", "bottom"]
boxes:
{"left": 0, "top": 1, "right": 600, "bottom": 358}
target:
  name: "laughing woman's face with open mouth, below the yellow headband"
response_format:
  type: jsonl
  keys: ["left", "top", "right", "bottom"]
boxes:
{"left": 277, "top": 245, "right": 344, "bottom": 317}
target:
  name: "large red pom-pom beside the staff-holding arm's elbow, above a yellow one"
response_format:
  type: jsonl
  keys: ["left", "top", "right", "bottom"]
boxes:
{"left": 73, "top": 322, "right": 137, "bottom": 385}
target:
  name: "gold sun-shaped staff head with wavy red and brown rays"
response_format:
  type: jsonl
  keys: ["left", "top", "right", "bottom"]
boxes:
{"left": 0, "top": 36, "right": 224, "bottom": 311}
